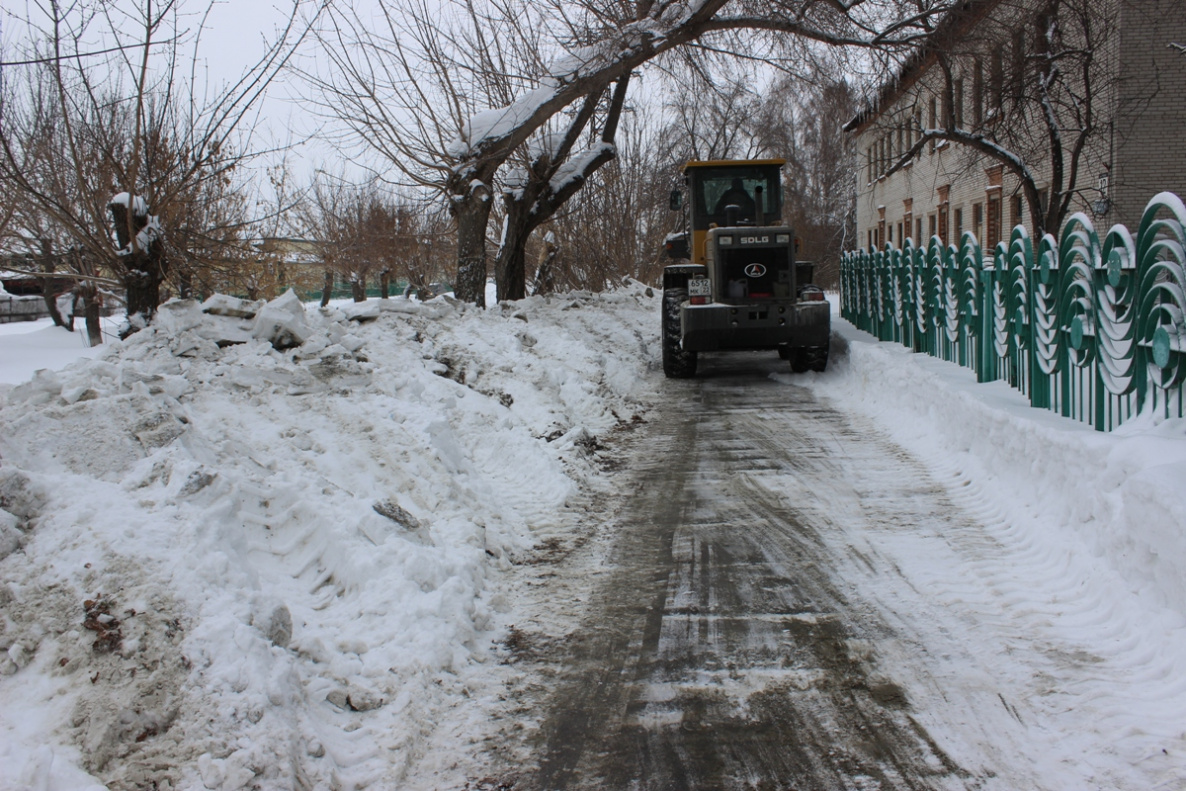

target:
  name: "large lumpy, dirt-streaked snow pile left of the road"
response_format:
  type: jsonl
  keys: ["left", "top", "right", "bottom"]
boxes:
{"left": 0, "top": 285, "right": 658, "bottom": 790}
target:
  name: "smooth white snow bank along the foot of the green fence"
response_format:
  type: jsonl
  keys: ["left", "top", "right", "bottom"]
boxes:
{"left": 812, "top": 320, "right": 1186, "bottom": 617}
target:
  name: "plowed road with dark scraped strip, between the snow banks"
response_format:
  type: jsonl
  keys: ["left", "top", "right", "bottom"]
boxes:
{"left": 450, "top": 346, "right": 1174, "bottom": 791}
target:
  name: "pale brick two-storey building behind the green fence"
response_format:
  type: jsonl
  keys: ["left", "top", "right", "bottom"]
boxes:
{"left": 846, "top": 0, "right": 1186, "bottom": 250}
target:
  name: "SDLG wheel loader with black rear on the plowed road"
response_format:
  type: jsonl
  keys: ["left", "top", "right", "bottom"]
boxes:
{"left": 662, "top": 159, "right": 831, "bottom": 378}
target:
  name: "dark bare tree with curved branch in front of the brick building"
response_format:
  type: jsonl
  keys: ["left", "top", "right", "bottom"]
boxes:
{"left": 876, "top": 0, "right": 1116, "bottom": 235}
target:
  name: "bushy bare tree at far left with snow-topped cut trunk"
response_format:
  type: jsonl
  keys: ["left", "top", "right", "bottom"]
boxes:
{"left": 0, "top": 0, "right": 317, "bottom": 343}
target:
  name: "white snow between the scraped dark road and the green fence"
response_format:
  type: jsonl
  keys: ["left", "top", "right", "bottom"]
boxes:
{"left": 786, "top": 323, "right": 1186, "bottom": 791}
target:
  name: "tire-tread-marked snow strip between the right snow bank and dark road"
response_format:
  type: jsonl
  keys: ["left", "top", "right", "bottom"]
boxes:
{"left": 863, "top": 434, "right": 1186, "bottom": 789}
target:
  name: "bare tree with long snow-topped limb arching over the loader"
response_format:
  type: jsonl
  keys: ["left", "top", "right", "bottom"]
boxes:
{"left": 317, "top": 0, "right": 954, "bottom": 302}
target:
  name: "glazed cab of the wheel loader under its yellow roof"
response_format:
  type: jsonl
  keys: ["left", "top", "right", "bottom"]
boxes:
{"left": 683, "top": 159, "right": 785, "bottom": 264}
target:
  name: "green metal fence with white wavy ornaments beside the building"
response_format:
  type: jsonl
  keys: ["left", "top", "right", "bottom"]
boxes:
{"left": 841, "top": 192, "right": 1186, "bottom": 430}
